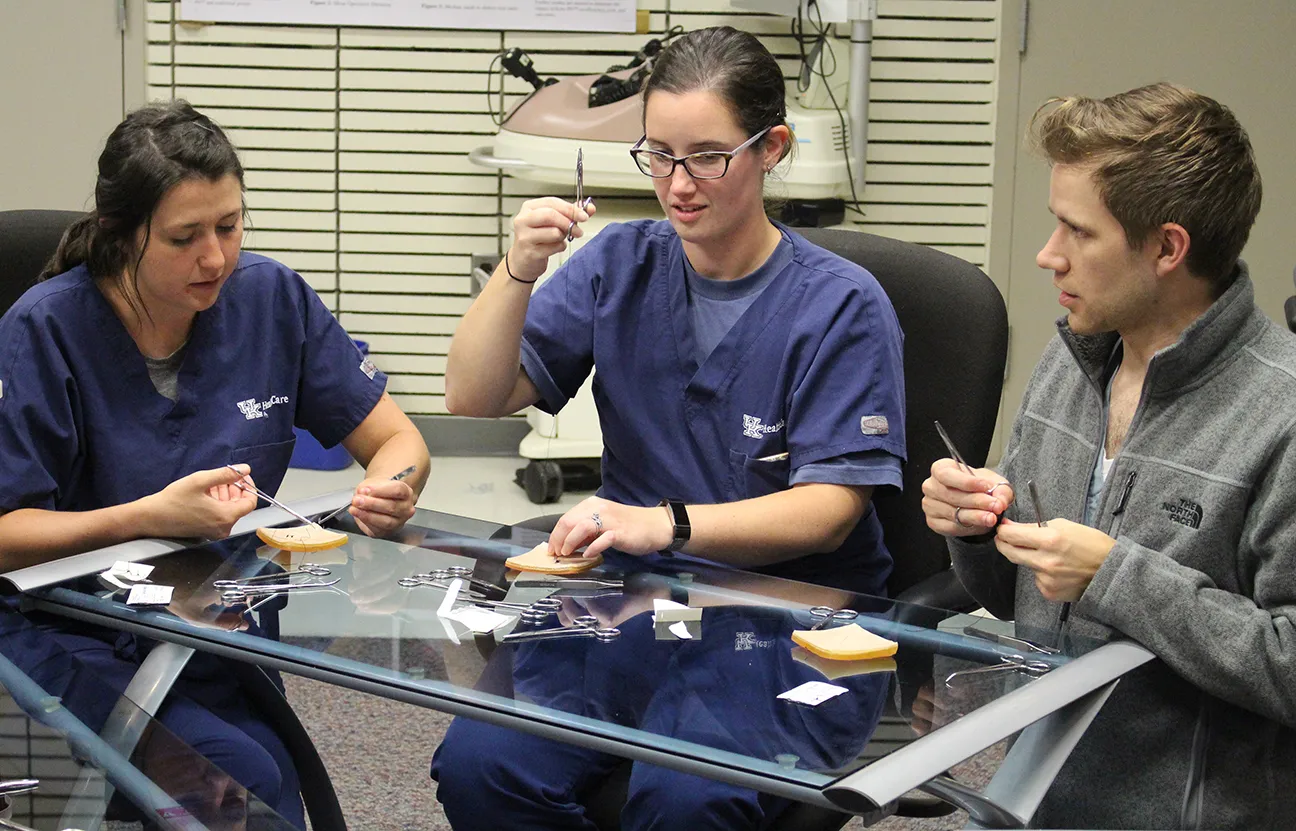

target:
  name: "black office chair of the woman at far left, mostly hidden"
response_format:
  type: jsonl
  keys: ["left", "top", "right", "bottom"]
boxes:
{"left": 0, "top": 210, "right": 346, "bottom": 831}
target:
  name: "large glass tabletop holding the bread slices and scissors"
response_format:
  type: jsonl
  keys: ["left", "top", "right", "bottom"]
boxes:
{"left": 12, "top": 509, "right": 1100, "bottom": 793}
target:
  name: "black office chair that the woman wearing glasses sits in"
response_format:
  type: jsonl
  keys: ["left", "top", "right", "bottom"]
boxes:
{"left": 505, "top": 228, "right": 1008, "bottom": 831}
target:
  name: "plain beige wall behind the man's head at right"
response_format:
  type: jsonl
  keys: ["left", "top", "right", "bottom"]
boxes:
{"left": 989, "top": 0, "right": 1296, "bottom": 453}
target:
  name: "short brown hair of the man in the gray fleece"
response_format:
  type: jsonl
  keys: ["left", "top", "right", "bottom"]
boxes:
{"left": 1030, "top": 83, "right": 1261, "bottom": 290}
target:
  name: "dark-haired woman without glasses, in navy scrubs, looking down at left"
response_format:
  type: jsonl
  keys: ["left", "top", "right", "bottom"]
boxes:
{"left": 0, "top": 101, "right": 428, "bottom": 825}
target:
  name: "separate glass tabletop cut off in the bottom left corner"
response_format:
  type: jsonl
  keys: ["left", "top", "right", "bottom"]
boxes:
{"left": 0, "top": 605, "right": 292, "bottom": 831}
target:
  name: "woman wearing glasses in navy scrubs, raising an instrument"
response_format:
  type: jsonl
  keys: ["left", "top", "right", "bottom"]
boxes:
{"left": 433, "top": 27, "right": 905, "bottom": 828}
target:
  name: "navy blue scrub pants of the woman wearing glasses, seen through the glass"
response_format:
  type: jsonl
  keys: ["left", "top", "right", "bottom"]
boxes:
{"left": 432, "top": 608, "right": 888, "bottom": 831}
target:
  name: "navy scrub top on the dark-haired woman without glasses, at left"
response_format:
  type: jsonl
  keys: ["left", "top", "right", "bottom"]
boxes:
{"left": 0, "top": 253, "right": 386, "bottom": 511}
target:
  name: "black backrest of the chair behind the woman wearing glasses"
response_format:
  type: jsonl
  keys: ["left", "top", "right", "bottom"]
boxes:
{"left": 797, "top": 228, "right": 1008, "bottom": 596}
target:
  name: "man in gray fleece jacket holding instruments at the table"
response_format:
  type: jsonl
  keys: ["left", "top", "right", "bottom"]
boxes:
{"left": 923, "top": 84, "right": 1296, "bottom": 828}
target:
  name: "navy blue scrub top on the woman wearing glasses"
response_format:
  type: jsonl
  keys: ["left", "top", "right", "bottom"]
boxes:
{"left": 522, "top": 220, "right": 905, "bottom": 594}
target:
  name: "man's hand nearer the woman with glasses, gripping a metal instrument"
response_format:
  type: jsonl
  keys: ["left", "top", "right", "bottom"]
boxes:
{"left": 923, "top": 459, "right": 1016, "bottom": 537}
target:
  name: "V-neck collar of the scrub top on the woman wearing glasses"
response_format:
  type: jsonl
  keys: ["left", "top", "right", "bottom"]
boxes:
{"left": 661, "top": 219, "right": 802, "bottom": 394}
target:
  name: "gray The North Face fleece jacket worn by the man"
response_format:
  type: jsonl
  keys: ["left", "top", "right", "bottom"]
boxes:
{"left": 950, "top": 266, "right": 1296, "bottom": 828}
